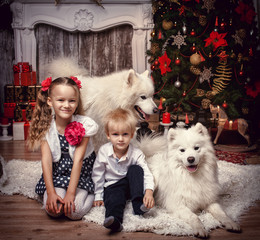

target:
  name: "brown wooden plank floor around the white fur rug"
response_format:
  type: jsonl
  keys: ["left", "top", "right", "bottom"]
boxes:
{"left": 0, "top": 141, "right": 260, "bottom": 240}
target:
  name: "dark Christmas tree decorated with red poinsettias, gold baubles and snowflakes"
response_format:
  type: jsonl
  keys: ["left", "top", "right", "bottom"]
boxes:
{"left": 147, "top": 0, "right": 259, "bottom": 124}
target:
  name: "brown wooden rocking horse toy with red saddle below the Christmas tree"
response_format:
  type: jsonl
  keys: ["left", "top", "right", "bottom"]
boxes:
{"left": 210, "top": 104, "right": 250, "bottom": 146}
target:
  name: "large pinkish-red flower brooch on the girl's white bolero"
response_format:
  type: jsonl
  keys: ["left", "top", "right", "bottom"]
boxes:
{"left": 64, "top": 121, "right": 85, "bottom": 146}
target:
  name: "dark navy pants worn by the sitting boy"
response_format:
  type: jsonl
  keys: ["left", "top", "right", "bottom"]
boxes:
{"left": 104, "top": 165, "right": 144, "bottom": 223}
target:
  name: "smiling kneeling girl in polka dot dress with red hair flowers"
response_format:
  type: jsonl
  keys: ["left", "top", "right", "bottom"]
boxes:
{"left": 28, "top": 77, "right": 98, "bottom": 220}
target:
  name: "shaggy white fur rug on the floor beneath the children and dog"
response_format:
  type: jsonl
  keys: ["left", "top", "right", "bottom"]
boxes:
{"left": 0, "top": 156, "right": 260, "bottom": 235}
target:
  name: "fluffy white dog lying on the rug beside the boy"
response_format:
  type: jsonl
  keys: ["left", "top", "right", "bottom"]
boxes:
{"left": 138, "top": 123, "right": 240, "bottom": 237}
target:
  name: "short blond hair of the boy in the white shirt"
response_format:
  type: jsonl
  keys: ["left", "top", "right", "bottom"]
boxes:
{"left": 103, "top": 108, "right": 137, "bottom": 135}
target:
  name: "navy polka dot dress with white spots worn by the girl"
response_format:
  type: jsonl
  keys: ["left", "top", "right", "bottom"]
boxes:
{"left": 35, "top": 134, "right": 96, "bottom": 195}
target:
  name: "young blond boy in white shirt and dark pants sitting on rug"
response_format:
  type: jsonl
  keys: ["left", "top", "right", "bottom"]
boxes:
{"left": 92, "top": 108, "right": 154, "bottom": 231}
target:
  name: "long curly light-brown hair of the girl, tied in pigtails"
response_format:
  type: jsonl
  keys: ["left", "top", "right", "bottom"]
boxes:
{"left": 27, "top": 77, "right": 84, "bottom": 150}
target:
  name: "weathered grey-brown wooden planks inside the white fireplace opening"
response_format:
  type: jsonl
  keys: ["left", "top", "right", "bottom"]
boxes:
{"left": 35, "top": 24, "right": 133, "bottom": 82}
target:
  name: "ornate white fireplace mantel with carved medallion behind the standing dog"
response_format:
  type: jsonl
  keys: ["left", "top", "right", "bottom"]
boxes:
{"left": 11, "top": 0, "right": 153, "bottom": 73}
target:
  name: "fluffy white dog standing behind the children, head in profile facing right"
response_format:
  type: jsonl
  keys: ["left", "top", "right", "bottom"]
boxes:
{"left": 48, "top": 58, "right": 157, "bottom": 150}
